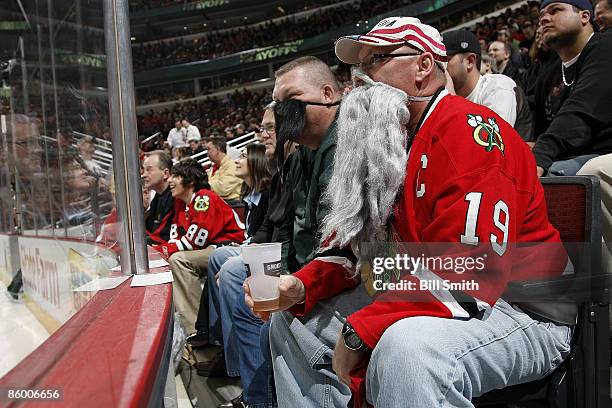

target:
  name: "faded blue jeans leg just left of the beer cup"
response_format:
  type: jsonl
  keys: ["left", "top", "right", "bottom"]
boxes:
{"left": 208, "top": 246, "right": 247, "bottom": 377}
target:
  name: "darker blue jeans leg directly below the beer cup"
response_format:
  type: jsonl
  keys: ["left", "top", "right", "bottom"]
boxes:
{"left": 234, "top": 297, "right": 274, "bottom": 408}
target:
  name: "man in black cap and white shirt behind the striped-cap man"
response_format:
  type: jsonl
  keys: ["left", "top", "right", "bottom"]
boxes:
{"left": 443, "top": 30, "right": 532, "bottom": 140}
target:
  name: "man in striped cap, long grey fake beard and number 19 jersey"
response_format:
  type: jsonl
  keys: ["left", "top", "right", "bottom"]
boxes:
{"left": 250, "top": 17, "right": 575, "bottom": 408}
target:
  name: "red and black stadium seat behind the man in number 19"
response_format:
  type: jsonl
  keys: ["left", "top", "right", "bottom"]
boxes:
{"left": 474, "top": 176, "right": 611, "bottom": 408}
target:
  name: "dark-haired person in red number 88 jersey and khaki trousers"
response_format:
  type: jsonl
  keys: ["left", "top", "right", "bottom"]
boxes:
{"left": 154, "top": 159, "right": 246, "bottom": 334}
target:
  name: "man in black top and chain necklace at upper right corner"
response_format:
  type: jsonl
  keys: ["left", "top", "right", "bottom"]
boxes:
{"left": 533, "top": 0, "right": 612, "bottom": 176}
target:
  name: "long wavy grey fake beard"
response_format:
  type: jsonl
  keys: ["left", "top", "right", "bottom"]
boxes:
{"left": 320, "top": 70, "right": 410, "bottom": 255}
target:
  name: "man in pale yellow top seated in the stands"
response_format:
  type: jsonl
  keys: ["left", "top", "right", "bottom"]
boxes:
{"left": 206, "top": 137, "right": 242, "bottom": 205}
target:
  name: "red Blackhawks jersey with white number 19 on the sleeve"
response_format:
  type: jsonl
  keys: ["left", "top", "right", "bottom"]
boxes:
{"left": 291, "top": 91, "right": 567, "bottom": 401}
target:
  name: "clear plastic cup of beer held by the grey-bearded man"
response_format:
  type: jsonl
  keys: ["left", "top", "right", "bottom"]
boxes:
{"left": 241, "top": 242, "right": 282, "bottom": 312}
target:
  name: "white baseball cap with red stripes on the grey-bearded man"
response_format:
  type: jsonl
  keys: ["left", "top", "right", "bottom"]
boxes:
{"left": 336, "top": 17, "right": 448, "bottom": 69}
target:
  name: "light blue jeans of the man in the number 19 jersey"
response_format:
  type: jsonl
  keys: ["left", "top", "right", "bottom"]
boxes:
{"left": 270, "top": 286, "right": 571, "bottom": 408}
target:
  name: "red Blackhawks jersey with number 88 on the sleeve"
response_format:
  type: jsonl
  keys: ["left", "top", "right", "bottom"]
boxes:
{"left": 154, "top": 189, "right": 246, "bottom": 258}
